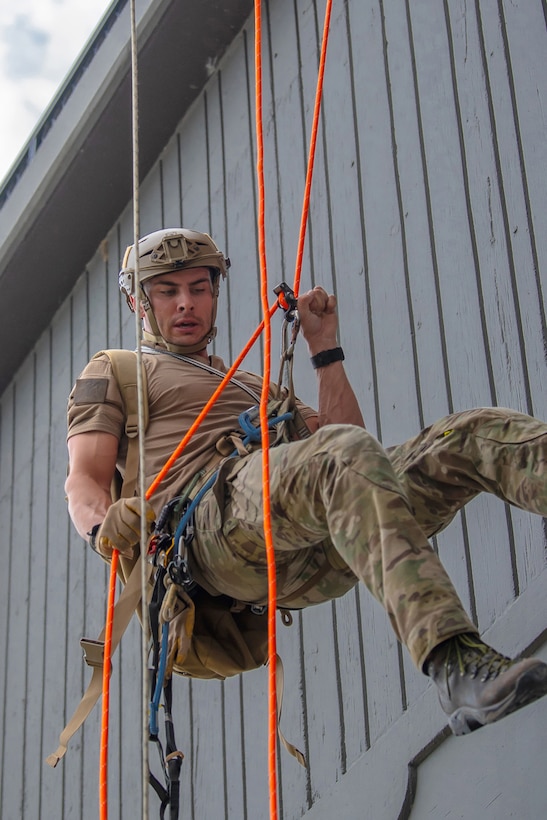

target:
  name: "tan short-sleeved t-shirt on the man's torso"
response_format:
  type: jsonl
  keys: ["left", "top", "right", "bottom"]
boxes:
{"left": 68, "top": 351, "right": 317, "bottom": 514}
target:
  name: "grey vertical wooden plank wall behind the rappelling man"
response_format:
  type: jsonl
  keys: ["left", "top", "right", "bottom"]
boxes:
{"left": 0, "top": 0, "right": 547, "bottom": 820}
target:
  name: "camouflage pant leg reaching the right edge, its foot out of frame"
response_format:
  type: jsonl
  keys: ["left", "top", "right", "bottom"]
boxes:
{"left": 388, "top": 407, "right": 547, "bottom": 536}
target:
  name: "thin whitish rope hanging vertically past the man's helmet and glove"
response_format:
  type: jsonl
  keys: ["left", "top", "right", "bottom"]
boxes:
{"left": 126, "top": 0, "right": 149, "bottom": 820}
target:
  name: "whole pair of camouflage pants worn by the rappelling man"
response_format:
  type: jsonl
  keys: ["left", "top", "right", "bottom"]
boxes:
{"left": 191, "top": 408, "right": 547, "bottom": 668}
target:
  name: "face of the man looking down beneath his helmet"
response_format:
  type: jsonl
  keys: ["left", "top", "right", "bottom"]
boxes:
{"left": 140, "top": 268, "right": 213, "bottom": 347}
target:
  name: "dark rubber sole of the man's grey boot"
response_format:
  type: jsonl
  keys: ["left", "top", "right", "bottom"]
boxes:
{"left": 448, "top": 664, "right": 547, "bottom": 736}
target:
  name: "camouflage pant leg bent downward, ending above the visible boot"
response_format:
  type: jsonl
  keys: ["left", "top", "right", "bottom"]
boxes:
{"left": 192, "top": 425, "right": 475, "bottom": 668}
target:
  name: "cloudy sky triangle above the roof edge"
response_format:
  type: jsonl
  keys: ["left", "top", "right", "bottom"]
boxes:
{"left": 0, "top": 0, "right": 112, "bottom": 185}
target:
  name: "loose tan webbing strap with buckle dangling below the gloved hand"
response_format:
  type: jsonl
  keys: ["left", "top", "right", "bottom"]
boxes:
{"left": 46, "top": 557, "right": 154, "bottom": 768}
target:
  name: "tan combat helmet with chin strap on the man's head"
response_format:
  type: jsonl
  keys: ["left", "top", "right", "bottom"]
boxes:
{"left": 118, "top": 228, "right": 230, "bottom": 355}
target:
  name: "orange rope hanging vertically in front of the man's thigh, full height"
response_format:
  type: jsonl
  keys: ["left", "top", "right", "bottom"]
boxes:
{"left": 255, "top": 0, "right": 277, "bottom": 820}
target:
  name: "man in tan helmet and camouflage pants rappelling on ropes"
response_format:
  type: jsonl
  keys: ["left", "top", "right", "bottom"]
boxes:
{"left": 66, "top": 229, "right": 547, "bottom": 734}
